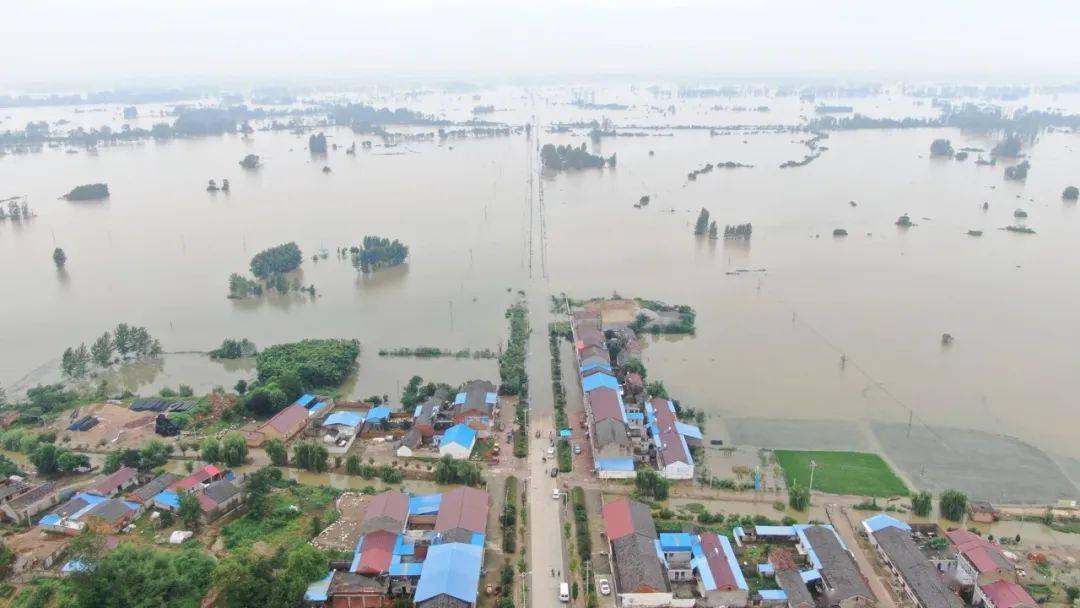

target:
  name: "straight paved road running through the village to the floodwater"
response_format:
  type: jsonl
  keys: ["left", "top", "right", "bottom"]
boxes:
{"left": 526, "top": 288, "right": 567, "bottom": 608}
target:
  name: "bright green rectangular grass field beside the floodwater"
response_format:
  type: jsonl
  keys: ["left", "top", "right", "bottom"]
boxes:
{"left": 774, "top": 449, "right": 907, "bottom": 498}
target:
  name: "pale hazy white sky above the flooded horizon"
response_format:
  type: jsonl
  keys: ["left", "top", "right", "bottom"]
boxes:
{"left": 0, "top": 0, "right": 1080, "bottom": 89}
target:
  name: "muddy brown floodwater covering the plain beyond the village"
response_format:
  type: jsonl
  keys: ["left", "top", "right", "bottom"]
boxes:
{"left": 6, "top": 85, "right": 1080, "bottom": 485}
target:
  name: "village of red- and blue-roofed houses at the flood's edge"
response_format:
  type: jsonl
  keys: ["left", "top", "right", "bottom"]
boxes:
{"left": 0, "top": 300, "right": 1080, "bottom": 608}
